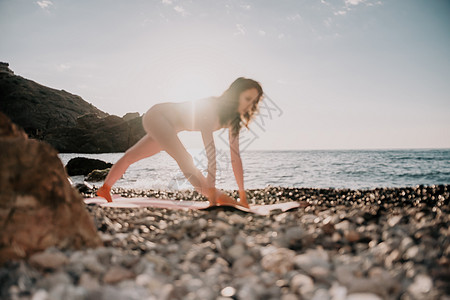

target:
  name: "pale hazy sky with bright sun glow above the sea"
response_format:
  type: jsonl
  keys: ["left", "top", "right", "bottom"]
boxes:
{"left": 0, "top": 0, "right": 450, "bottom": 150}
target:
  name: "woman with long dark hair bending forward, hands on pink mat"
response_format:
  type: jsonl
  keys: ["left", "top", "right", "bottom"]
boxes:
{"left": 97, "top": 77, "right": 263, "bottom": 208}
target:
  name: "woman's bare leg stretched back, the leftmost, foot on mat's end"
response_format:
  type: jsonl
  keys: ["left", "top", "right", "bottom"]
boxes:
{"left": 97, "top": 134, "right": 162, "bottom": 202}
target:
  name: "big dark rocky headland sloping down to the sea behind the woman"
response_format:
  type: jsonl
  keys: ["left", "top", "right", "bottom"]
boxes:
{"left": 0, "top": 63, "right": 145, "bottom": 153}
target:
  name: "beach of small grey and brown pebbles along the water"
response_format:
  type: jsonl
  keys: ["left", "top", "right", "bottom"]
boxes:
{"left": 0, "top": 185, "right": 450, "bottom": 300}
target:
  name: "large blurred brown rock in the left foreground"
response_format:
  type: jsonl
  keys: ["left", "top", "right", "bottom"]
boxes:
{"left": 0, "top": 113, "right": 102, "bottom": 264}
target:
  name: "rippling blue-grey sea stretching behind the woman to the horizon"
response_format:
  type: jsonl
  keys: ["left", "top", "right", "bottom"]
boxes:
{"left": 60, "top": 149, "right": 450, "bottom": 190}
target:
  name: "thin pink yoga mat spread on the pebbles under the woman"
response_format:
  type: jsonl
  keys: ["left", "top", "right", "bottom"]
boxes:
{"left": 84, "top": 195, "right": 307, "bottom": 215}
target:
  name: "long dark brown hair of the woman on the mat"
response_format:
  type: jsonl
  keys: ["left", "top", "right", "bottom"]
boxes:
{"left": 217, "top": 77, "right": 263, "bottom": 135}
